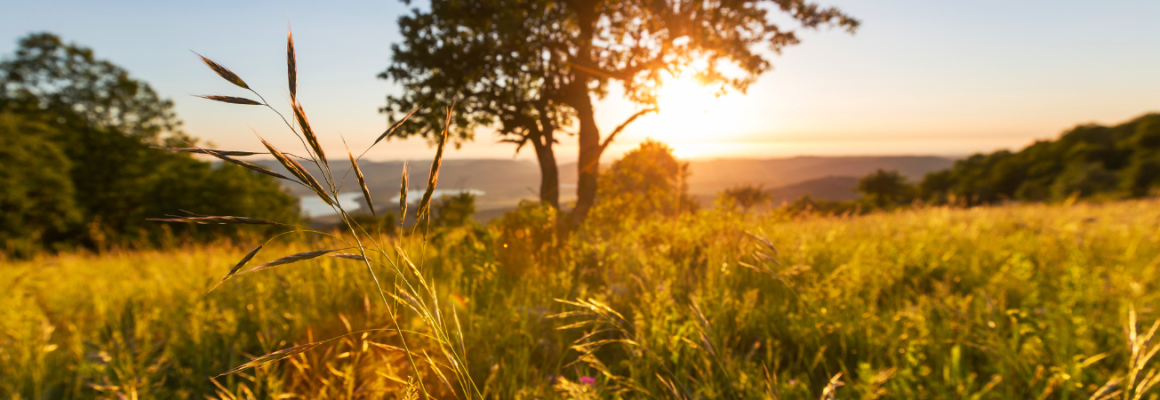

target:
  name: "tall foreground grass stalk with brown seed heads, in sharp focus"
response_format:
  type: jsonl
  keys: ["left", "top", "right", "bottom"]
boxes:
{"left": 168, "top": 31, "right": 481, "bottom": 399}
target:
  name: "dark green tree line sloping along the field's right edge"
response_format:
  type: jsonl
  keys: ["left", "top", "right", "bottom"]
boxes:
{"left": 718, "top": 114, "right": 1160, "bottom": 213}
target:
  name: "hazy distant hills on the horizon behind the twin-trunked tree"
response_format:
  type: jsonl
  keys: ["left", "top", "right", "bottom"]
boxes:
{"left": 258, "top": 155, "right": 954, "bottom": 219}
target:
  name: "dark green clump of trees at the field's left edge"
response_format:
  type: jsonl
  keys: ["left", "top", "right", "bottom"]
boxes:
{"left": 0, "top": 34, "right": 299, "bottom": 256}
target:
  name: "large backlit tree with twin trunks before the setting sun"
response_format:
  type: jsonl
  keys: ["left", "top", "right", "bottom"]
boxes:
{"left": 380, "top": 0, "right": 858, "bottom": 223}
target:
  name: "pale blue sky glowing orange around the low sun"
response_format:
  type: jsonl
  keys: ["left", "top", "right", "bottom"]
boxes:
{"left": 0, "top": 0, "right": 1160, "bottom": 162}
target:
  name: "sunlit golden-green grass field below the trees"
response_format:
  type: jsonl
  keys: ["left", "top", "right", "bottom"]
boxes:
{"left": 0, "top": 201, "right": 1160, "bottom": 399}
